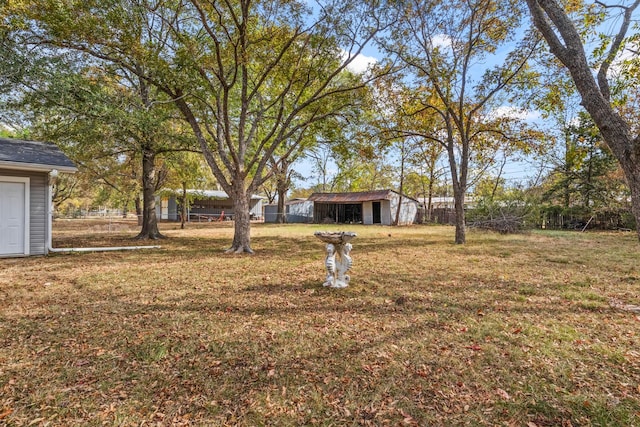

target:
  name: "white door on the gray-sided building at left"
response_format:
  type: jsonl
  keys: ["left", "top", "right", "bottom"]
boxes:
{"left": 0, "top": 177, "right": 29, "bottom": 255}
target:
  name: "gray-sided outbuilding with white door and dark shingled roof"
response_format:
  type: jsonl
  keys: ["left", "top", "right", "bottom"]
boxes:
{"left": 0, "top": 138, "right": 78, "bottom": 257}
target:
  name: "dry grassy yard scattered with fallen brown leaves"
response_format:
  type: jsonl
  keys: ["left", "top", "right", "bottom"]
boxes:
{"left": 0, "top": 220, "right": 640, "bottom": 427}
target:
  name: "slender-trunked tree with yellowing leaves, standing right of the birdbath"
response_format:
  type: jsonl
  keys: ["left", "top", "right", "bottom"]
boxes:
{"left": 384, "top": 0, "right": 537, "bottom": 243}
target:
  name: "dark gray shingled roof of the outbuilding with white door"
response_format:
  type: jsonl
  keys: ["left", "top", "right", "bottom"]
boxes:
{"left": 0, "top": 138, "right": 77, "bottom": 171}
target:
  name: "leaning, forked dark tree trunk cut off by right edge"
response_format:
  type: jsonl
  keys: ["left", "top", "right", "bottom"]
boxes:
{"left": 527, "top": 0, "right": 640, "bottom": 239}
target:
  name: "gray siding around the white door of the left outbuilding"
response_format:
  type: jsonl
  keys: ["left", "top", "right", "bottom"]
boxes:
{"left": 0, "top": 169, "right": 48, "bottom": 255}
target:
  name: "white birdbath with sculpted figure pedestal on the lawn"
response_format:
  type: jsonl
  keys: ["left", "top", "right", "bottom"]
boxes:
{"left": 314, "top": 231, "right": 356, "bottom": 288}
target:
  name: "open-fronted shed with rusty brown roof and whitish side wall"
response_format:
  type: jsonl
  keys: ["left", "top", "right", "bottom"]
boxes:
{"left": 308, "top": 190, "right": 420, "bottom": 225}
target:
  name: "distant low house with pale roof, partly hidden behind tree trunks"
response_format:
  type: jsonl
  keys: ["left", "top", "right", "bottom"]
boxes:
{"left": 156, "top": 190, "right": 264, "bottom": 221}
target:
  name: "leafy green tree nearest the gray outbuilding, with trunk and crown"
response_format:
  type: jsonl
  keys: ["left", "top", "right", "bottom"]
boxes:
{"left": 0, "top": 6, "right": 204, "bottom": 239}
